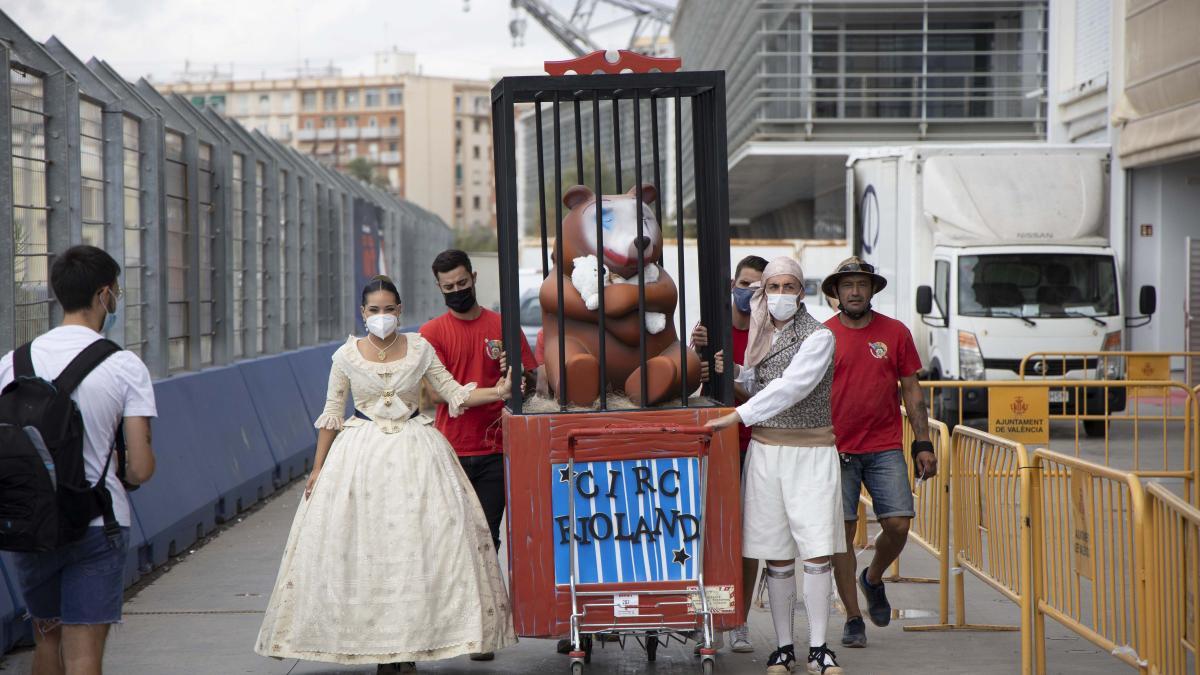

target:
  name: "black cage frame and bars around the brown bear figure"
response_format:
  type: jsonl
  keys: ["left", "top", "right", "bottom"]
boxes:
{"left": 492, "top": 71, "right": 733, "bottom": 413}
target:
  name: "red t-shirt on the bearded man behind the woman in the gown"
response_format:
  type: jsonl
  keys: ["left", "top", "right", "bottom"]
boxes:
{"left": 421, "top": 307, "right": 538, "bottom": 456}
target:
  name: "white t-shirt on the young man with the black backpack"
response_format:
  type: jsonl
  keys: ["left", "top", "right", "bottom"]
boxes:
{"left": 0, "top": 325, "right": 157, "bottom": 527}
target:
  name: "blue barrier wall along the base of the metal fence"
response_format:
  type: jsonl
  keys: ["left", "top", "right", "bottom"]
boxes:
{"left": 0, "top": 336, "right": 350, "bottom": 652}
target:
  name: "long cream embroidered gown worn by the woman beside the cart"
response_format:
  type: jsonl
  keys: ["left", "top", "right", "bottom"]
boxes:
{"left": 254, "top": 333, "right": 516, "bottom": 663}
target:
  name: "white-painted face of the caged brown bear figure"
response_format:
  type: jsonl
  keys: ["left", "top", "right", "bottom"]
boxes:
{"left": 582, "top": 195, "right": 662, "bottom": 279}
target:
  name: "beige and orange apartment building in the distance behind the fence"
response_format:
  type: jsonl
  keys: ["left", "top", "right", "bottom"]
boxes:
{"left": 158, "top": 52, "right": 496, "bottom": 228}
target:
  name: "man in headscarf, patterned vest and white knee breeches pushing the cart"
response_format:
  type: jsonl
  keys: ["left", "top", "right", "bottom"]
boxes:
{"left": 709, "top": 257, "right": 846, "bottom": 675}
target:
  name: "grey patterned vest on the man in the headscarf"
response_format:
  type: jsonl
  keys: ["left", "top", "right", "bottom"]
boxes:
{"left": 755, "top": 304, "right": 833, "bottom": 446}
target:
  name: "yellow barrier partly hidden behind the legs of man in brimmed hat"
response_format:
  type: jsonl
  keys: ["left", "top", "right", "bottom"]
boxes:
{"left": 854, "top": 407, "right": 950, "bottom": 623}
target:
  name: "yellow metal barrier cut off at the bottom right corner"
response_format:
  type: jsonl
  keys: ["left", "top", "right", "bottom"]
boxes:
{"left": 1145, "top": 483, "right": 1200, "bottom": 675}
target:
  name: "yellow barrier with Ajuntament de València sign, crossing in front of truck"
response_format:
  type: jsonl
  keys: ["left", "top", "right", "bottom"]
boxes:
{"left": 922, "top": 380, "right": 1200, "bottom": 504}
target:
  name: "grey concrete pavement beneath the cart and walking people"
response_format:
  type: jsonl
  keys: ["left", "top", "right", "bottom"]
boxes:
{"left": 0, "top": 482, "right": 1128, "bottom": 675}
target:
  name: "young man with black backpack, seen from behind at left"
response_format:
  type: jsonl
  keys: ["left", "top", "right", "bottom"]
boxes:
{"left": 0, "top": 246, "right": 156, "bottom": 674}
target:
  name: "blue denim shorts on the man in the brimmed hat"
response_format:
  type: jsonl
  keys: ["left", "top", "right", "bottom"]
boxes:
{"left": 841, "top": 450, "right": 917, "bottom": 521}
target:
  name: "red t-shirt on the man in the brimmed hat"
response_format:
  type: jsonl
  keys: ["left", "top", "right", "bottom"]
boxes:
{"left": 826, "top": 312, "right": 920, "bottom": 454}
